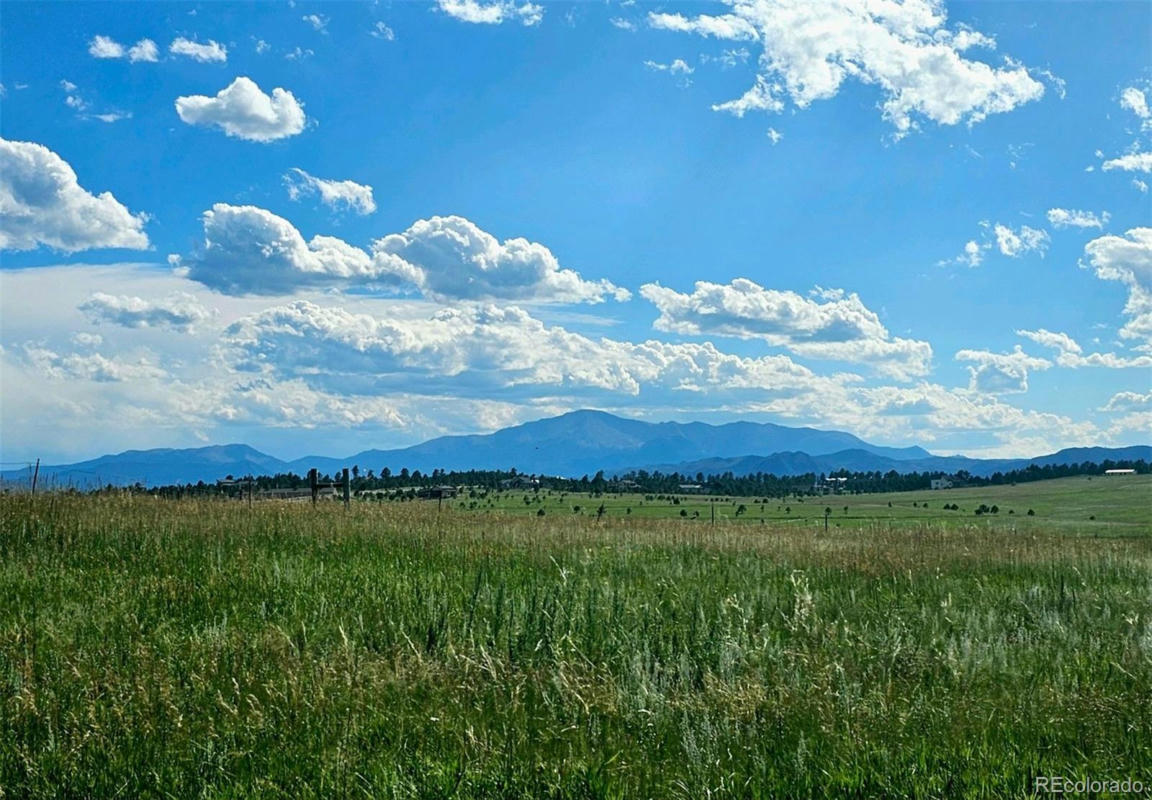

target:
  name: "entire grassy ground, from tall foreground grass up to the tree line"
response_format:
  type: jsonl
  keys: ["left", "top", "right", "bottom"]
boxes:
{"left": 0, "top": 478, "right": 1152, "bottom": 798}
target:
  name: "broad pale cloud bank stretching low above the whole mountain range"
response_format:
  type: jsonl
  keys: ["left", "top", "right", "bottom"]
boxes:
{"left": 0, "top": 265, "right": 1124, "bottom": 461}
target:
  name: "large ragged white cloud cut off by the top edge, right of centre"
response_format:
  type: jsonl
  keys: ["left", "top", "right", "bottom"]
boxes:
{"left": 649, "top": 0, "right": 1044, "bottom": 134}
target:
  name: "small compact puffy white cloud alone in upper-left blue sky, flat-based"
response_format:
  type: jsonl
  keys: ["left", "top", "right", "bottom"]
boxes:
{"left": 176, "top": 76, "right": 305, "bottom": 142}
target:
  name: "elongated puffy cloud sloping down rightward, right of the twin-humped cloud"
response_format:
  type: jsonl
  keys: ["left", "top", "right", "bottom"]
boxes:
{"left": 641, "top": 278, "right": 932, "bottom": 379}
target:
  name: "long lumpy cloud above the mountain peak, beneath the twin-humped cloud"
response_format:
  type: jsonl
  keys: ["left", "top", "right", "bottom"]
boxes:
{"left": 225, "top": 301, "right": 827, "bottom": 400}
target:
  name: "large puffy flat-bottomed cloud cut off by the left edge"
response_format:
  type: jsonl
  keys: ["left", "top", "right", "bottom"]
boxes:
{"left": 0, "top": 139, "right": 149, "bottom": 252}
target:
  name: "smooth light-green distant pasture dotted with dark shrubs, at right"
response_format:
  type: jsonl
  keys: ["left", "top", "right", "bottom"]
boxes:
{"left": 453, "top": 475, "right": 1152, "bottom": 535}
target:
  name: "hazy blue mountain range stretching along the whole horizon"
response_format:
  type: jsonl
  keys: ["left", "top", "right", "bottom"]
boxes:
{"left": 0, "top": 410, "right": 1152, "bottom": 488}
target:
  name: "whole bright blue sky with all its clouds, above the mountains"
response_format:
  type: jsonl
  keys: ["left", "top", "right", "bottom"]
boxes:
{"left": 0, "top": 0, "right": 1152, "bottom": 460}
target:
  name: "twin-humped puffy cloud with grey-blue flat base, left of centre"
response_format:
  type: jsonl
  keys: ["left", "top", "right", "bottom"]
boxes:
{"left": 188, "top": 203, "right": 628, "bottom": 303}
